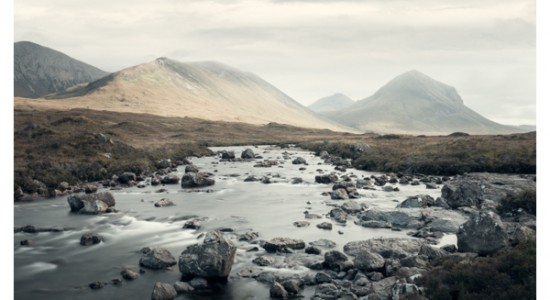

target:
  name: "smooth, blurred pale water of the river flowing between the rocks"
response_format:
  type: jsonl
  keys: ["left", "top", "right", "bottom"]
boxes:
{"left": 14, "top": 146, "right": 455, "bottom": 299}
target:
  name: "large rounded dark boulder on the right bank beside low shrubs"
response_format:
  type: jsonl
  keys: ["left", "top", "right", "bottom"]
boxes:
{"left": 456, "top": 211, "right": 508, "bottom": 255}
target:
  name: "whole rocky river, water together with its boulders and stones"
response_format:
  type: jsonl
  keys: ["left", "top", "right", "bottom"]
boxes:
{"left": 14, "top": 146, "right": 536, "bottom": 299}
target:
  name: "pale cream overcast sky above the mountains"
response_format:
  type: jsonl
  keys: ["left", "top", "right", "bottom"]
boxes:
{"left": 14, "top": 0, "right": 536, "bottom": 125}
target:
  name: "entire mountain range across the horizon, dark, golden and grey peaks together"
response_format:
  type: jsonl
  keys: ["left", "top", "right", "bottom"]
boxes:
{"left": 14, "top": 42, "right": 526, "bottom": 135}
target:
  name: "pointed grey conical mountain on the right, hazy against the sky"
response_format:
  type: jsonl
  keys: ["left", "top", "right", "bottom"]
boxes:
{"left": 325, "top": 70, "right": 523, "bottom": 135}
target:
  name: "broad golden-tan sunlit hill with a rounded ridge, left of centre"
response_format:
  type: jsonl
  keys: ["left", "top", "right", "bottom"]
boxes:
{"left": 16, "top": 58, "right": 357, "bottom": 132}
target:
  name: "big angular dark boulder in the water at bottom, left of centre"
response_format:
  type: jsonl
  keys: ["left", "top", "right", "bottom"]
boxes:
{"left": 178, "top": 231, "right": 237, "bottom": 281}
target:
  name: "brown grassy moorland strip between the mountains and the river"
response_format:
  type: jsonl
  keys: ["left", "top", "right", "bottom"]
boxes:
{"left": 14, "top": 109, "right": 536, "bottom": 200}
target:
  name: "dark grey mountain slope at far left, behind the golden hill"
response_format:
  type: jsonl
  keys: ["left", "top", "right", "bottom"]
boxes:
{"left": 13, "top": 42, "right": 108, "bottom": 98}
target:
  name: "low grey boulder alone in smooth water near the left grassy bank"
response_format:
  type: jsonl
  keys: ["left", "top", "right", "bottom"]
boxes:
{"left": 67, "top": 192, "right": 116, "bottom": 215}
